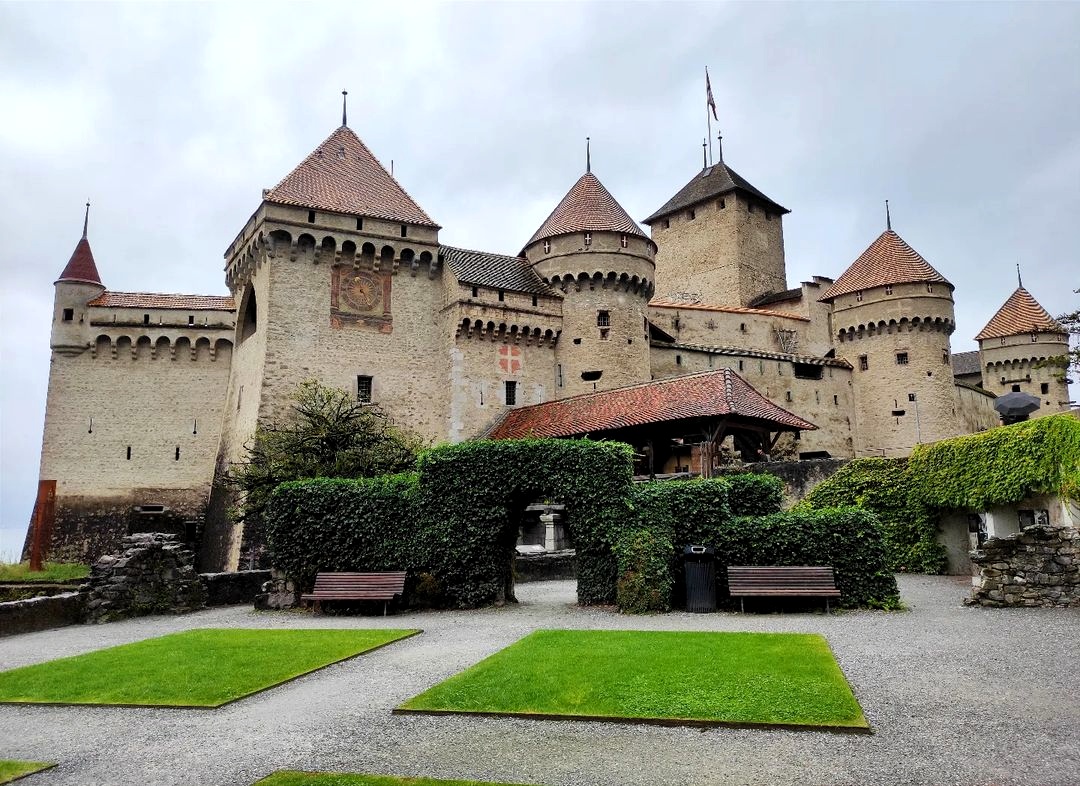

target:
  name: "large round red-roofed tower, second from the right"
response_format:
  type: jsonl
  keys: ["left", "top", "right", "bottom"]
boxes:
{"left": 821, "top": 228, "right": 960, "bottom": 456}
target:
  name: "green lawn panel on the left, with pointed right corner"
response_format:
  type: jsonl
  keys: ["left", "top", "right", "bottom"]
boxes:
{"left": 0, "top": 628, "right": 420, "bottom": 707}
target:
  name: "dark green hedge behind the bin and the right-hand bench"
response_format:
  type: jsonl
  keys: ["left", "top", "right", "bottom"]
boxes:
{"left": 617, "top": 475, "right": 897, "bottom": 612}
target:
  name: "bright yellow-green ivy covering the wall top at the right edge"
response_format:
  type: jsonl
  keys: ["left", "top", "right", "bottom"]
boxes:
{"left": 910, "top": 415, "right": 1080, "bottom": 511}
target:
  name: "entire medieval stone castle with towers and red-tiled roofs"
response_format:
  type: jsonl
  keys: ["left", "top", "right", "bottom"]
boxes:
{"left": 33, "top": 113, "right": 1068, "bottom": 569}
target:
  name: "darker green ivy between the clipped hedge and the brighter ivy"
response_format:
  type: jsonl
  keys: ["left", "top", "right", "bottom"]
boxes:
{"left": 797, "top": 459, "right": 947, "bottom": 573}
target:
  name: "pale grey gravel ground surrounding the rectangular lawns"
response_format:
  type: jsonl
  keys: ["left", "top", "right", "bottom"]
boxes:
{"left": 0, "top": 577, "right": 1080, "bottom": 786}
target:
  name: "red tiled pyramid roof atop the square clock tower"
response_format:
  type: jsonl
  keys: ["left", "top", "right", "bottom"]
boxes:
{"left": 266, "top": 125, "right": 438, "bottom": 228}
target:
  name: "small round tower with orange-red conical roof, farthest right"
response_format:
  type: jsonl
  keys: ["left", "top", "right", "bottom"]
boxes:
{"left": 975, "top": 282, "right": 1069, "bottom": 417}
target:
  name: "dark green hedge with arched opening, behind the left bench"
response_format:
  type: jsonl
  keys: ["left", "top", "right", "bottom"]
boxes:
{"left": 267, "top": 439, "right": 633, "bottom": 608}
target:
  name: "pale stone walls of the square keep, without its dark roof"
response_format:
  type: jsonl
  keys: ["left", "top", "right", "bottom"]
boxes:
{"left": 651, "top": 193, "right": 787, "bottom": 306}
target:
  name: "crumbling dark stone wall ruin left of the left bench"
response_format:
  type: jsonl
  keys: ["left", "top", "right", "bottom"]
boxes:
{"left": 86, "top": 532, "right": 206, "bottom": 622}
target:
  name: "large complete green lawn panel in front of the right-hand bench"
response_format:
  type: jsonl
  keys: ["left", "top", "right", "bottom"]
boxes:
{"left": 395, "top": 631, "right": 869, "bottom": 732}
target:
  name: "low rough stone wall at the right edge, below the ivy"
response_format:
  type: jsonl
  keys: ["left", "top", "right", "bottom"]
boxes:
{"left": 964, "top": 527, "right": 1080, "bottom": 606}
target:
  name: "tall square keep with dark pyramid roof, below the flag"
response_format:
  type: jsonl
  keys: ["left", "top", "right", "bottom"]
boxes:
{"left": 645, "top": 153, "right": 791, "bottom": 307}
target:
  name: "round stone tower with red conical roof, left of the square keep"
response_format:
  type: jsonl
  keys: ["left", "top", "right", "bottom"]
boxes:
{"left": 523, "top": 171, "right": 657, "bottom": 398}
